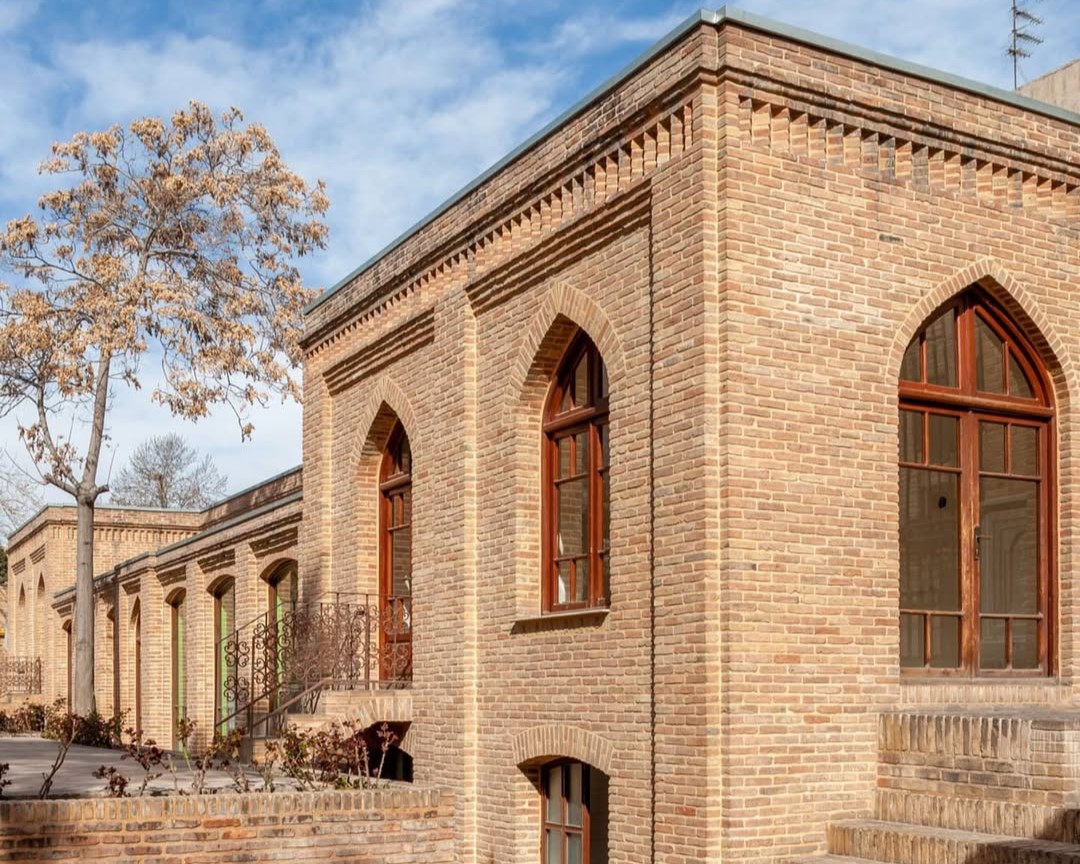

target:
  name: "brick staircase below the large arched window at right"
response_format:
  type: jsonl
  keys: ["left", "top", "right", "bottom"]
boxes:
{"left": 795, "top": 706, "right": 1080, "bottom": 864}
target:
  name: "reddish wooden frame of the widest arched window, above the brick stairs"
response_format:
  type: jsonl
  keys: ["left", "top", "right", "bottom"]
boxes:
{"left": 897, "top": 286, "right": 1057, "bottom": 678}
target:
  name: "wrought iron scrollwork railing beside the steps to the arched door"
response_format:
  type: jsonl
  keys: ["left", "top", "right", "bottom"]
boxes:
{"left": 216, "top": 594, "right": 413, "bottom": 738}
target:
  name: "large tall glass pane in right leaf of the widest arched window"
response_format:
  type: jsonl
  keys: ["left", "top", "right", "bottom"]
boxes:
{"left": 978, "top": 477, "right": 1039, "bottom": 613}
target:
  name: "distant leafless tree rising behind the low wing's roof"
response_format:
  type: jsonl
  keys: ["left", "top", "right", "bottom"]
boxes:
{"left": 109, "top": 432, "right": 228, "bottom": 510}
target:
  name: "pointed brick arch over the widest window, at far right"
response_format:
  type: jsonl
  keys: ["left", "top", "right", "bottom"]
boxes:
{"left": 889, "top": 258, "right": 1075, "bottom": 406}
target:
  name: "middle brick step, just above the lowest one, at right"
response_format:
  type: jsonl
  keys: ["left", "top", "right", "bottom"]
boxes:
{"left": 874, "top": 788, "right": 1080, "bottom": 843}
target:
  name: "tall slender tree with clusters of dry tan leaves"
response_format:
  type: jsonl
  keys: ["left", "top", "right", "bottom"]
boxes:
{"left": 0, "top": 103, "right": 327, "bottom": 715}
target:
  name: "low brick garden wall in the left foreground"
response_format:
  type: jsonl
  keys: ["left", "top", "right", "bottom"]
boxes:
{"left": 0, "top": 788, "right": 457, "bottom": 864}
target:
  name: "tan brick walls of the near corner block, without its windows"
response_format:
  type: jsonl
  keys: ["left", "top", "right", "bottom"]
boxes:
{"left": 12, "top": 13, "right": 1080, "bottom": 864}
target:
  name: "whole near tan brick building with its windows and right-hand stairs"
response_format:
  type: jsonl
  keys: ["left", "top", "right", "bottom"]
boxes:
{"left": 13, "top": 10, "right": 1080, "bottom": 864}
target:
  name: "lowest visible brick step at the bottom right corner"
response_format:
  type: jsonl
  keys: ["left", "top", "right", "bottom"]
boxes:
{"left": 828, "top": 819, "right": 1080, "bottom": 864}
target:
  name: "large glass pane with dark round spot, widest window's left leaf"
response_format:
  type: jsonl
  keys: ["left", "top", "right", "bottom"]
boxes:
{"left": 900, "top": 468, "right": 960, "bottom": 609}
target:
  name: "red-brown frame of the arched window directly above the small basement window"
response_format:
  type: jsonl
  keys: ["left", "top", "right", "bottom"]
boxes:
{"left": 541, "top": 330, "right": 610, "bottom": 612}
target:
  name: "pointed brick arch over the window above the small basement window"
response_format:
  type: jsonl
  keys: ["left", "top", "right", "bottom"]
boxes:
{"left": 508, "top": 283, "right": 624, "bottom": 409}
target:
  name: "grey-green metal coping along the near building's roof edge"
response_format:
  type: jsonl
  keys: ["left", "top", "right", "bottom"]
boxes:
{"left": 303, "top": 5, "right": 1080, "bottom": 314}
